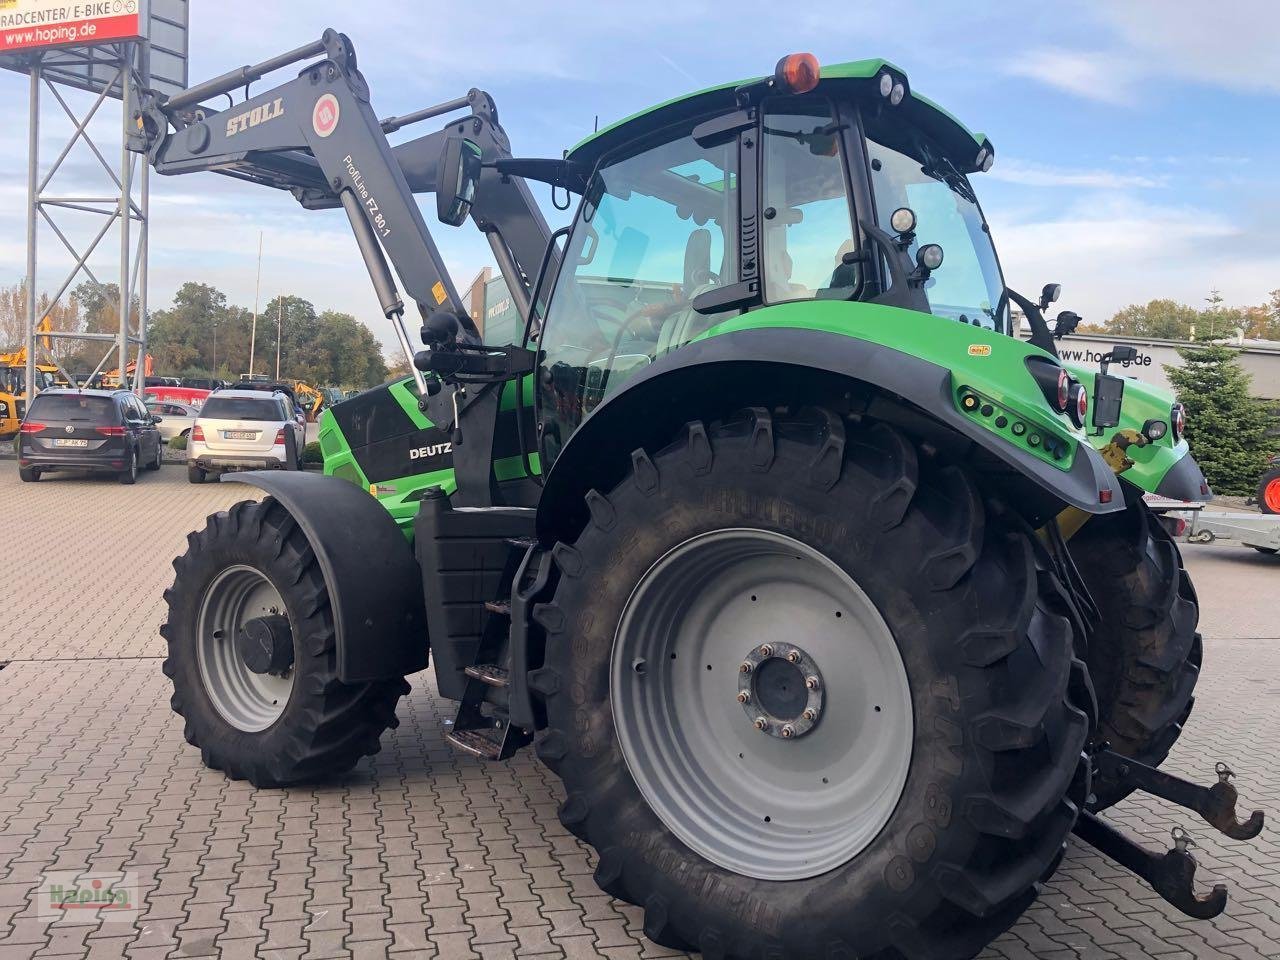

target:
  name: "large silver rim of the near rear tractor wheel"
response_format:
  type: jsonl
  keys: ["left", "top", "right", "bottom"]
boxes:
{"left": 611, "top": 529, "right": 914, "bottom": 881}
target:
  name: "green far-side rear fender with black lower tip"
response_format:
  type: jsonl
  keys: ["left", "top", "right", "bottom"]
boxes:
{"left": 1062, "top": 364, "right": 1213, "bottom": 502}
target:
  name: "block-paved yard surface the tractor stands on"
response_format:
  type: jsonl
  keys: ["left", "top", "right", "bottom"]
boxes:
{"left": 0, "top": 460, "right": 1280, "bottom": 960}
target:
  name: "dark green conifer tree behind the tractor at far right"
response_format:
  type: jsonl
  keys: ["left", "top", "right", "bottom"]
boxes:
{"left": 1165, "top": 344, "right": 1276, "bottom": 495}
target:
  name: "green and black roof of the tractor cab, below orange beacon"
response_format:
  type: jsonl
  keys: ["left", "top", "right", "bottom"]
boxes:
{"left": 566, "top": 59, "right": 995, "bottom": 173}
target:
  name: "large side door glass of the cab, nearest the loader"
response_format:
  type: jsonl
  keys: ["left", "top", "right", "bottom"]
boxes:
{"left": 539, "top": 122, "right": 737, "bottom": 461}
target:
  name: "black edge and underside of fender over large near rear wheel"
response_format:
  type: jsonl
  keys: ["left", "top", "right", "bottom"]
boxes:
{"left": 538, "top": 321, "right": 1124, "bottom": 540}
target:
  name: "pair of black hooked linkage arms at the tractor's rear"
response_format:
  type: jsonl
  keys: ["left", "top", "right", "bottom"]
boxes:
{"left": 1073, "top": 746, "right": 1263, "bottom": 920}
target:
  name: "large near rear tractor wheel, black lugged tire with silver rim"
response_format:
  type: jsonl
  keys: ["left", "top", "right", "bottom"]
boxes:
{"left": 531, "top": 408, "right": 1089, "bottom": 960}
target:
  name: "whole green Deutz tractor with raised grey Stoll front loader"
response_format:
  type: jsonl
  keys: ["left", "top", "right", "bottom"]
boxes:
{"left": 133, "top": 31, "right": 1262, "bottom": 959}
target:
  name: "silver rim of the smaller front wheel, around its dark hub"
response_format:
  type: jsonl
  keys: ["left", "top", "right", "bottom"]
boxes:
{"left": 196, "top": 564, "right": 294, "bottom": 733}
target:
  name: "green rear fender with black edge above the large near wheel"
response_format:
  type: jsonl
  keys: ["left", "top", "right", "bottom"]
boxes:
{"left": 538, "top": 316, "right": 1124, "bottom": 540}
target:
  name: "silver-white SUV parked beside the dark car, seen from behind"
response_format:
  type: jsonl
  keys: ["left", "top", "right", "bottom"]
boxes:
{"left": 187, "top": 390, "right": 306, "bottom": 484}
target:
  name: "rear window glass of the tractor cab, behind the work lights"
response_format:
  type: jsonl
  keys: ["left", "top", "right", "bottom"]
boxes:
{"left": 867, "top": 125, "right": 1007, "bottom": 332}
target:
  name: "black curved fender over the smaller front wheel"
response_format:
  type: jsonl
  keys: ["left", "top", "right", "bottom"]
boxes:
{"left": 223, "top": 471, "right": 428, "bottom": 684}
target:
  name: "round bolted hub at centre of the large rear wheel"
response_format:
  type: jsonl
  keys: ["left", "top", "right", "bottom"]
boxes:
{"left": 737, "top": 643, "right": 826, "bottom": 740}
